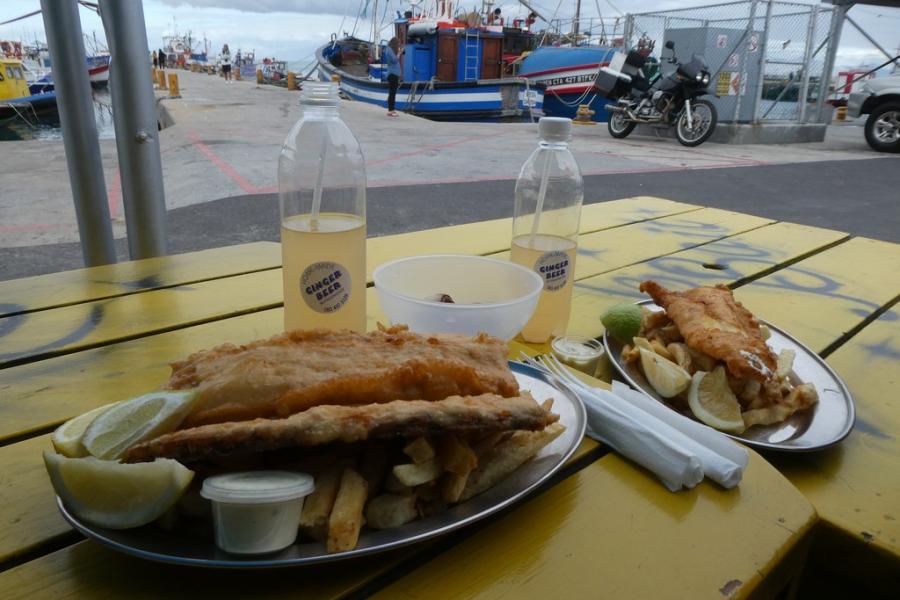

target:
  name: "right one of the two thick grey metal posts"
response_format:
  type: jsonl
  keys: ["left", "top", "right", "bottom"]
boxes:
{"left": 100, "top": 0, "right": 166, "bottom": 259}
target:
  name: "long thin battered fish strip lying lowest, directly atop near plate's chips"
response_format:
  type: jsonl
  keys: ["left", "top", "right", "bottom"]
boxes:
{"left": 124, "top": 394, "right": 559, "bottom": 462}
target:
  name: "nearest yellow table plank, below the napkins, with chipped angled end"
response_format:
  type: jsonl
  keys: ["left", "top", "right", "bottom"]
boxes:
{"left": 374, "top": 452, "right": 815, "bottom": 600}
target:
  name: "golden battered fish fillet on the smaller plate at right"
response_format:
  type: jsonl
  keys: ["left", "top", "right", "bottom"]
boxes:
{"left": 640, "top": 280, "right": 778, "bottom": 382}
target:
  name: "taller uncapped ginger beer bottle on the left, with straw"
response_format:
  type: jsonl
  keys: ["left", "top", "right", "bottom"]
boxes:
{"left": 278, "top": 83, "right": 366, "bottom": 332}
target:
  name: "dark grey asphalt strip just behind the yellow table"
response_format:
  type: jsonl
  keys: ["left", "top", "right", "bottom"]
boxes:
{"left": 0, "top": 156, "right": 900, "bottom": 280}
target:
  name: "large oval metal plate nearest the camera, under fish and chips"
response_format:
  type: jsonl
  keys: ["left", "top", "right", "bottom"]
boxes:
{"left": 56, "top": 362, "right": 585, "bottom": 569}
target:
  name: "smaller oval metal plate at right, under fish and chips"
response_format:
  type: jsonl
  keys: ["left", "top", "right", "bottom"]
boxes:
{"left": 603, "top": 300, "right": 856, "bottom": 452}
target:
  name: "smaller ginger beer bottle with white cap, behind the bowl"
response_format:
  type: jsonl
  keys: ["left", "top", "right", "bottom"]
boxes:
{"left": 511, "top": 117, "right": 584, "bottom": 343}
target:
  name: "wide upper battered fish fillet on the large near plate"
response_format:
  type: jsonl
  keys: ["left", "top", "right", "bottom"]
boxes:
{"left": 165, "top": 327, "right": 519, "bottom": 428}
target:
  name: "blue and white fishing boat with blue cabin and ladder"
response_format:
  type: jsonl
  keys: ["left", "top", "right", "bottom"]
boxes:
{"left": 316, "top": 1, "right": 544, "bottom": 120}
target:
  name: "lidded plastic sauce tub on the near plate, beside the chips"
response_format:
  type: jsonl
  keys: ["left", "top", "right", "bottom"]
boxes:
{"left": 200, "top": 471, "right": 315, "bottom": 554}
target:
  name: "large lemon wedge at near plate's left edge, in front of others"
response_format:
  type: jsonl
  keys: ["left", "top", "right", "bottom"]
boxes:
{"left": 44, "top": 451, "right": 194, "bottom": 529}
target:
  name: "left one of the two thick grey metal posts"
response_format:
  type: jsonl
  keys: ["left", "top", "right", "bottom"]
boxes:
{"left": 41, "top": 0, "right": 117, "bottom": 267}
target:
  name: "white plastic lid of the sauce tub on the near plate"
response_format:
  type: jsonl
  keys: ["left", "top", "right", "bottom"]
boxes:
{"left": 200, "top": 471, "right": 316, "bottom": 504}
